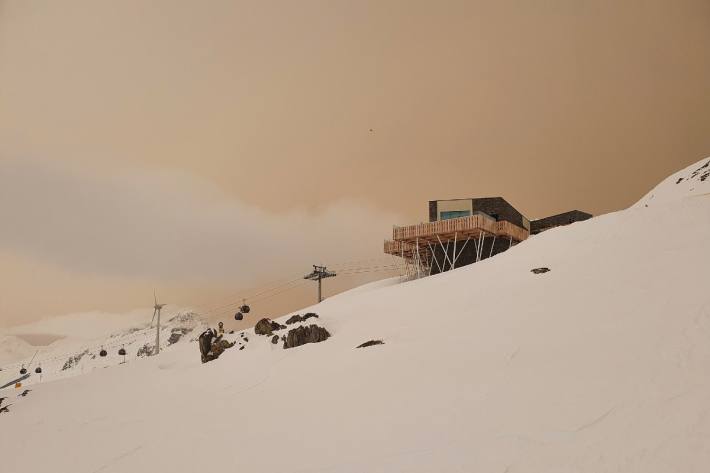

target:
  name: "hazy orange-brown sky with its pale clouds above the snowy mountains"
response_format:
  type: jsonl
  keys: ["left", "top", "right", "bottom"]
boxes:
{"left": 0, "top": 0, "right": 710, "bottom": 325}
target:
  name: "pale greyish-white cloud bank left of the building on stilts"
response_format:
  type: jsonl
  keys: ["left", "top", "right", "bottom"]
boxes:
{"left": 0, "top": 159, "right": 395, "bottom": 284}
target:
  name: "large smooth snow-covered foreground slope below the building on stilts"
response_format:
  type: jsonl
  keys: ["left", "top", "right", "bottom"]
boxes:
{"left": 0, "top": 160, "right": 710, "bottom": 473}
